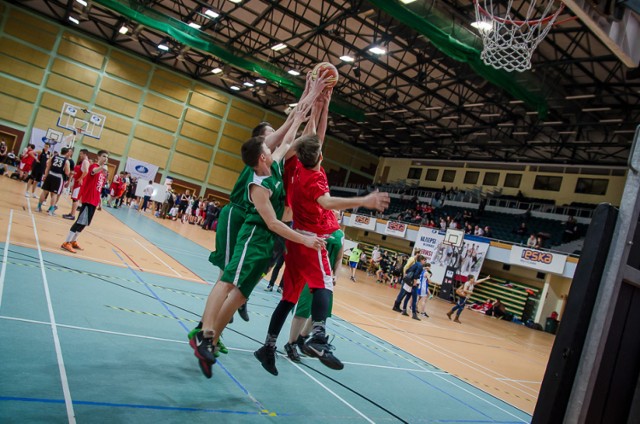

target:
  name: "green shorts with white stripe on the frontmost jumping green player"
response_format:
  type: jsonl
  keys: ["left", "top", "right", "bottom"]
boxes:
{"left": 220, "top": 224, "right": 275, "bottom": 298}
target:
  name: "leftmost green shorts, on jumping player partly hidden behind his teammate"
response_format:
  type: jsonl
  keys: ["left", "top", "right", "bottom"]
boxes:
{"left": 209, "top": 203, "right": 246, "bottom": 271}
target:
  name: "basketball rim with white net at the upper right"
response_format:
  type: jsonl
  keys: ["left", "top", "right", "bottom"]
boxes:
{"left": 474, "top": 0, "right": 564, "bottom": 72}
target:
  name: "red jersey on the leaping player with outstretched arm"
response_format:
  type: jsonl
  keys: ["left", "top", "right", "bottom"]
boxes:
{"left": 284, "top": 156, "right": 340, "bottom": 235}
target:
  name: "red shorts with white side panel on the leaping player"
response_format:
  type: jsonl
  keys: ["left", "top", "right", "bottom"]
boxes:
{"left": 282, "top": 240, "right": 333, "bottom": 303}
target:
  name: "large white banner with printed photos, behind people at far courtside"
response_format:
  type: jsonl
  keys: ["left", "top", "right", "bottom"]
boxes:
{"left": 415, "top": 227, "right": 489, "bottom": 284}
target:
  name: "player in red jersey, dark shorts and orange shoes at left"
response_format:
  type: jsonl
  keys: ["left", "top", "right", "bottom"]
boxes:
{"left": 60, "top": 150, "right": 109, "bottom": 253}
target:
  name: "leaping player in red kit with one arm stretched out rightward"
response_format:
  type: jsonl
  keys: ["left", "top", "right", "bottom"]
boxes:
{"left": 254, "top": 91, "right": 389, "bottom": 375}
